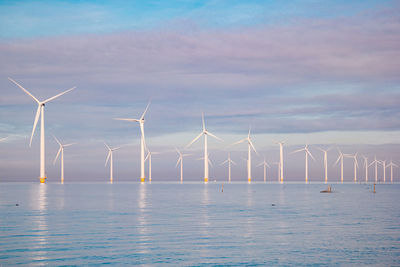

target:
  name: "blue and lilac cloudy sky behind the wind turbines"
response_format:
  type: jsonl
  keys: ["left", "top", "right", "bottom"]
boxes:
{"left": 0, "top": 0, "right": 400, "bottom": 182}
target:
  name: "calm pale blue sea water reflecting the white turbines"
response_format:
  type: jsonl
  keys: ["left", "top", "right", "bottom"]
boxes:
{"left": 0, "top": 183, "right": 400, "bottom": 266}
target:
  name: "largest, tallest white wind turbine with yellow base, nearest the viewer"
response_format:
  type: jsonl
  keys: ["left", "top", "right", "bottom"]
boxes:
{"left": 8, "top": 78, "right": 76, "bottom": 183}
